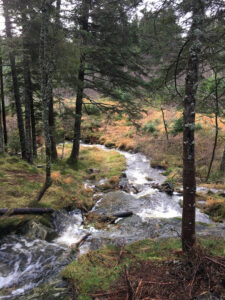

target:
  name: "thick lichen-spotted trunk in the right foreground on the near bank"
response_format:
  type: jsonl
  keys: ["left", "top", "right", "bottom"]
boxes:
{"left": 182, "top": 0, "right": 204, "bottom": 251}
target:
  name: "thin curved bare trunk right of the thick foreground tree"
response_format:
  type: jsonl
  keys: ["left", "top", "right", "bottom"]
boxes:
{"left": 206, "top": 71, "right": 219, "bottom": 182}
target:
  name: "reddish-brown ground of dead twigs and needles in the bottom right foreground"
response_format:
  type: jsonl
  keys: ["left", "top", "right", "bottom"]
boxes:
{"left": 90, "top": 253, "right": 225, "bottom": 300}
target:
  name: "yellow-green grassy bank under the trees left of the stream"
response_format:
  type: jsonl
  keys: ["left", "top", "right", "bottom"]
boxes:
{"left": 0, "top": 145, "right": 126, "bottom": 231}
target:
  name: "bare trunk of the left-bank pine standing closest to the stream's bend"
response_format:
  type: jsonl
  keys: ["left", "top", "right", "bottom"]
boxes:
{"left": 69, "top": 0, "right": 90, "bottom": 164}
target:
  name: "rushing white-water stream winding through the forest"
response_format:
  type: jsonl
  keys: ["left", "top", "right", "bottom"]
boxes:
{"left": 0, "top": 145, "right": 225, "bottom": 300}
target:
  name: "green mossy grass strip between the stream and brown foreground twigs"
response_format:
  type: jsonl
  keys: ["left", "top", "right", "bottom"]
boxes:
{"left": 62, "top": 238, "right": 225, "bottom": 300}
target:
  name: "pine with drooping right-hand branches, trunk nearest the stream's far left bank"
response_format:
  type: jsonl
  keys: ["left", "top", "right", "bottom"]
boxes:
{"left": 69, "top": 0, "right": 143, "bottom": 163}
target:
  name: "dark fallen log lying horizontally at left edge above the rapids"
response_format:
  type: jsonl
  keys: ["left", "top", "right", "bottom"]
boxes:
{"left": 0, "top": 208, "right": 54, "bottom": 216}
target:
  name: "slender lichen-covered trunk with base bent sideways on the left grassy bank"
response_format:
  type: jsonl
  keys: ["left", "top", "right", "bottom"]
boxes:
{"left": 37, "top": 0, "right": 54, "bottom": 201}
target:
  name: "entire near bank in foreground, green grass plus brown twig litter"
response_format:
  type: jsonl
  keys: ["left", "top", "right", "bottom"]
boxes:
{"left": 62, "top": 238, "right": 225, "bottom": 300}
